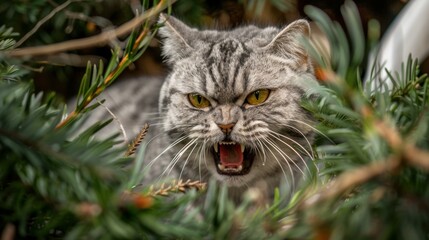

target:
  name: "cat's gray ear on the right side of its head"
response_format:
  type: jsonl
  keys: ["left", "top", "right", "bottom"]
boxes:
{"left": 264, "top": 19, "right": 310, "bottom": 69}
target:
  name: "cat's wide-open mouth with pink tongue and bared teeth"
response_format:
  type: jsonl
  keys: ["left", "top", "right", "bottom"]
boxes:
{"left": 213, "top": 142, "right": 255, "bottom": 175}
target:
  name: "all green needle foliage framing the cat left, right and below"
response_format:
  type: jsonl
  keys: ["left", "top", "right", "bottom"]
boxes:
{"left": 0, "top": 1, "right": 429, "bottom": 239}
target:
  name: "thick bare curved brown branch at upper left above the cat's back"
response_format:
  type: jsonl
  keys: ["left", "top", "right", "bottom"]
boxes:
{"left": 7, "top": 0, "right": 177, "bottom": 57}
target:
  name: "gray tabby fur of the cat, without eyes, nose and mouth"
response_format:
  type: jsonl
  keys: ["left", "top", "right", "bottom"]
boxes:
{"left": 84, "top": 15, "right": 314, "bottom": 201}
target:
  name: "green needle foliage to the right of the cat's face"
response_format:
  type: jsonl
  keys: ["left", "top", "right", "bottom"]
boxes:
{"left": 288, "top": 1, "right": 429, "bottom": 239}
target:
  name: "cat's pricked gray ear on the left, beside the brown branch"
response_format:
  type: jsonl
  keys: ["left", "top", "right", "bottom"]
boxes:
{"left": 159, "top": 13, "right": 198, "bottom": 63}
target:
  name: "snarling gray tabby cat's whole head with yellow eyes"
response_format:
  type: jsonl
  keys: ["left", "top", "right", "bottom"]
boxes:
{"left": 159, "top": 16, "right": 314, "bottom": 186}
